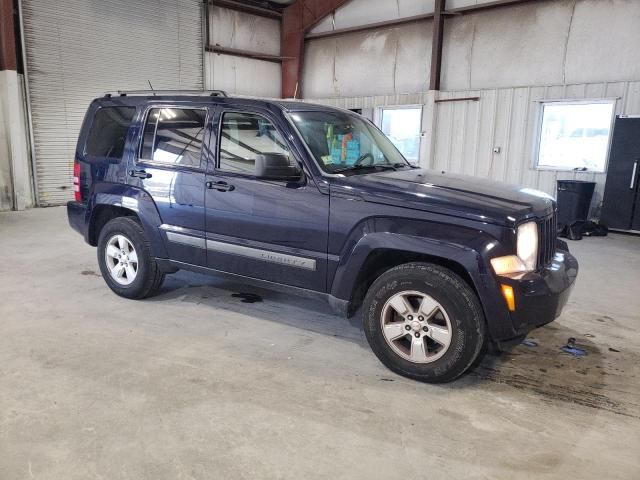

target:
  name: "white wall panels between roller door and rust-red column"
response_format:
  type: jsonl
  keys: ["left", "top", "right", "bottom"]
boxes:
{"left": 205, "top": 7, "right": 282, "bottom": 98}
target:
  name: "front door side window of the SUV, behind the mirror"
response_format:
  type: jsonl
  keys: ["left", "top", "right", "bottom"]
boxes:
{"left": 218, "top": 113, "right": 291, "bottom": 175}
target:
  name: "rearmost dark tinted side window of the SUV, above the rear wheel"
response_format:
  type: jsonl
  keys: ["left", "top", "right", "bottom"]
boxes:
{"left": 84, "top": 107, "right": 136, "bottom": 158}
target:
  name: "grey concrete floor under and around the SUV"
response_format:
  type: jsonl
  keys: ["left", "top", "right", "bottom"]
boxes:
{"left": 0, "top": 208, "right": 640, "bottom": 480}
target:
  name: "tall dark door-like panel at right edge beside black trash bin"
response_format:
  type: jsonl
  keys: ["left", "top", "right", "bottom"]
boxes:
{"left": 601, "top": 117, "right": 640, "bottom": 230}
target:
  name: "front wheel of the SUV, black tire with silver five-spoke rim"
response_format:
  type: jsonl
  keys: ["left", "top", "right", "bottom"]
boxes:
{"left": 363, "top": 263, "right": 486, "bottom": 383}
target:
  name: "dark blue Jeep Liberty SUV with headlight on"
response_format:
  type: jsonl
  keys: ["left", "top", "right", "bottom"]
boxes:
{"left": 67, "top": 91, "right": 578, "bottom": 382}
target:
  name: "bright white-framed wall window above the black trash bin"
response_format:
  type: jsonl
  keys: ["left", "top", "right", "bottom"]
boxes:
{"left": 536, "top": 101, "right": 615, "bottom": 172}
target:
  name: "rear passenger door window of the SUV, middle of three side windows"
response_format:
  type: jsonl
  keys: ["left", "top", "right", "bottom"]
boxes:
{"left": 140, "top": 108, "right": 207, "bottom": 167}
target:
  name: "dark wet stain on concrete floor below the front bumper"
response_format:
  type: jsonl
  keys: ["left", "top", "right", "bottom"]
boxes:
{"left": 465, "top": 319, "right": 640, "bottom": 419}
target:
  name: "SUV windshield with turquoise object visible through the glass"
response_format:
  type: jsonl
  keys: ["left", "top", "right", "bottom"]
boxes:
{"left": 291, "top": 111, "right": 410, "bottom": 173}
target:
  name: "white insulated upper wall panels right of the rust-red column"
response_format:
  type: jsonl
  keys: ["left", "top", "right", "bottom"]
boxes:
{"left": 303, "top": 0, "right": 640, "bottom": 98}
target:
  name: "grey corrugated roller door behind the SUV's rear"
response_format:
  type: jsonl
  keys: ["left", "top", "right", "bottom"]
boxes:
{"left": 22, "top": 0, "right": 203, "bottom": 206}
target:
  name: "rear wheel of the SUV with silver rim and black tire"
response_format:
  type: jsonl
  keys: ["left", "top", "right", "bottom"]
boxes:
{"left": 98, "top": 217, "right": 165, "bottom": 299}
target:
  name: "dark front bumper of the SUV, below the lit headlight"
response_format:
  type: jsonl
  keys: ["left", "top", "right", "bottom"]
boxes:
{"left": 495, "top": 250, "right": 578, "bottom": 347}
